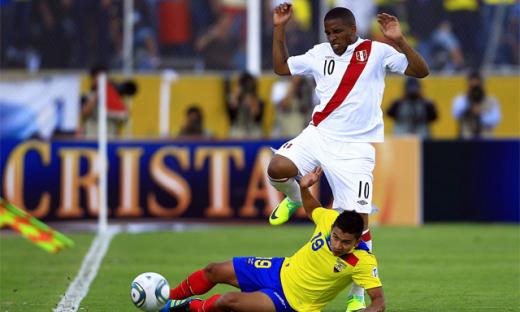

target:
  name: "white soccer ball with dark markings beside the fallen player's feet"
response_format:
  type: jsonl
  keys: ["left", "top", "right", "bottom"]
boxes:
{"left": 130, "top": 272, "right": 170, "bottom": 312}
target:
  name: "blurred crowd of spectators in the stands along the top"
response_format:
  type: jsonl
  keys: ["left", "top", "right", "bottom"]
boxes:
{"left": 0, "top": 0, "right": 520, "bottom": 72}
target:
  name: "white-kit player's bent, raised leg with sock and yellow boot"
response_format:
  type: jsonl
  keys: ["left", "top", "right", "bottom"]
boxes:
{"left": 267, "top": 155, "right": 302, "bottom": 225}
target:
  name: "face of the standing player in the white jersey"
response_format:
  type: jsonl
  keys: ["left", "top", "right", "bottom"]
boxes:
{"left": 325, "top": 18, "right": 356, "bottom": 55}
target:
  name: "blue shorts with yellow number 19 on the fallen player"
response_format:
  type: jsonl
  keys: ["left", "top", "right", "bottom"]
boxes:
{"left": 233, "top": 257, "right": 295, "bottom": 312}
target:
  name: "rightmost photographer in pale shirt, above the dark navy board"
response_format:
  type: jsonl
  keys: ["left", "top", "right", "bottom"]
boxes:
{"left": 452, "top": 72, "right": 500, "bottom": 139}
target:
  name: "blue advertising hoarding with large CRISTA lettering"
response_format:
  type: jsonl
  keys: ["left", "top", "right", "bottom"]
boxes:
{"left": 0, "top": 141, "right": 330, "bottom": 220}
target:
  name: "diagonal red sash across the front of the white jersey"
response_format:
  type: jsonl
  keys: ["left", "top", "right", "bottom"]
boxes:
{"left": 312, "top": 40, "right": 372, "bottom": 126}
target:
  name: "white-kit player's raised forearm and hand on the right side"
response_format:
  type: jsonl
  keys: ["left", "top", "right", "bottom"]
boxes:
{"left": 377, "top": 13, "right": 430, "bottom": 78}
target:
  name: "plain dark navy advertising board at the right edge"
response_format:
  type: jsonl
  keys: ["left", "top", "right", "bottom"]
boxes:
{"left": 423, "top": 140, "right": 520, "bottom": 223}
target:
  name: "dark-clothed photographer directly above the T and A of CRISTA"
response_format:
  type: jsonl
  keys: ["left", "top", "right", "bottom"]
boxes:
{"left": 228, "top": 72, "right": 265, "bottom": 138}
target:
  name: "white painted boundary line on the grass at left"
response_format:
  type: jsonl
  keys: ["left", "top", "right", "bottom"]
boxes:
{"left": 54, "top": 226, "right": 120, "bottom": 312}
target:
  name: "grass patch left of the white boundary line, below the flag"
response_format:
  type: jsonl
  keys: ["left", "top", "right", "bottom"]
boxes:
{"left": 0, "top": 234, "right": 94, "bottom": 312}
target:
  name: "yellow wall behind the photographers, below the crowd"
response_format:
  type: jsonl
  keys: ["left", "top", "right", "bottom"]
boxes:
{"left": 81, "top": 74, "right": 520, "bottom": 139}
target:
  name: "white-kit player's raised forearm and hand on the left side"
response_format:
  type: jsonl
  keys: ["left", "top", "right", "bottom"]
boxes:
{"left": 273, "top": 3, "right": 292, "bottom": 76}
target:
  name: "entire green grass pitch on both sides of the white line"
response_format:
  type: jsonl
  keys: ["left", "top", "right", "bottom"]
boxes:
{"left": 0, "top": 224, "right": 520, "bottom": 312}
